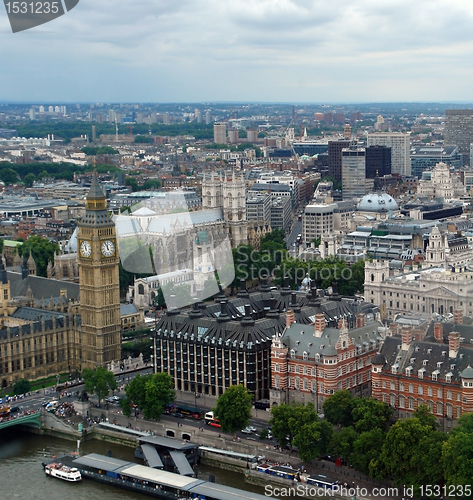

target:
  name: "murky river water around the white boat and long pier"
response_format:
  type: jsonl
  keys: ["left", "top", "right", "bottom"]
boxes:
{"left": 0, "top": 428, "right": 264, "bottom": 500}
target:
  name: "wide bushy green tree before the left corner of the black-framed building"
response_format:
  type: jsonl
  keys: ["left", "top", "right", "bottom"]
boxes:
{"left": 121, "top": 373, "right": 176, "bottom": 420}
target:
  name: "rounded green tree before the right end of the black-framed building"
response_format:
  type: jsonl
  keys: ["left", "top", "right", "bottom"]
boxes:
{"left": 213, "top": 384, "right": 253, "bottom": 433}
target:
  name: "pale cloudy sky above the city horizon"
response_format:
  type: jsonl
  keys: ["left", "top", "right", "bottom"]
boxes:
{"left": 0, "top": 0, "right": 473, "bottom": 104}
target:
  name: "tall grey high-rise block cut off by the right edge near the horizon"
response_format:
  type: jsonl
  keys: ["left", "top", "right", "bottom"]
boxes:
{"left": 444, "top": 109, "right": 473, "bottom": 165}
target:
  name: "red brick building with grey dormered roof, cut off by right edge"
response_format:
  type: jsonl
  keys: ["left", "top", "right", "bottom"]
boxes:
{"left": 372, "top": 311, "right": 473, "bottom": 431}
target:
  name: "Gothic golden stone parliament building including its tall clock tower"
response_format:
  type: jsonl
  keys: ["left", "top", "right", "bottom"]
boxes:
{"left": 0, "top": 174, "right": 121, "bottom": 387}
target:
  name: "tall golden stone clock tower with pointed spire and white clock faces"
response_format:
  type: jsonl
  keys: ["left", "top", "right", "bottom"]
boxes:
{"left": 77, "top": 172, "right": 121, "bottom": 369}
